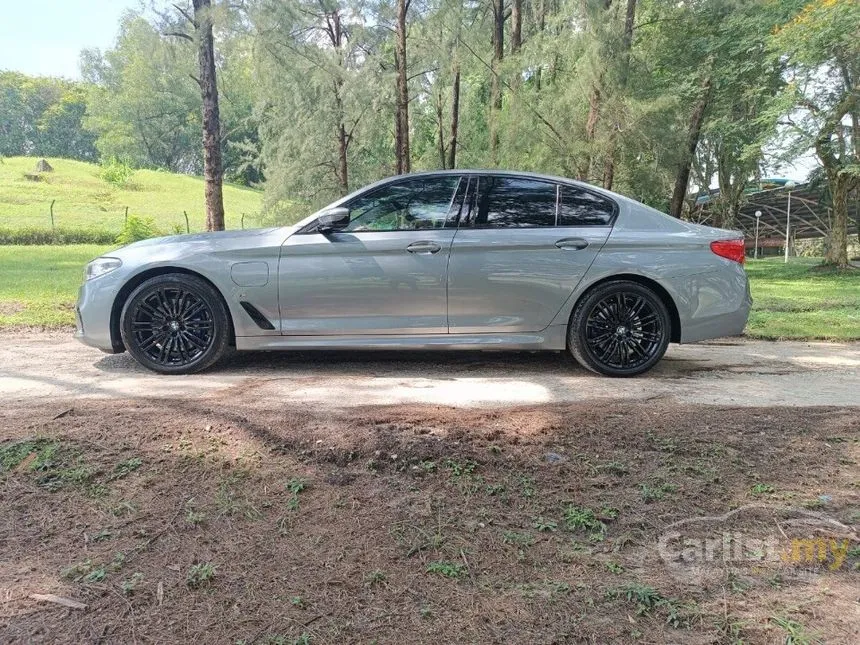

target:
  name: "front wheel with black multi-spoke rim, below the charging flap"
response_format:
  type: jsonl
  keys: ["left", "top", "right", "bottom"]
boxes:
{"left": 120, "top": 273, "right": 231, "bottom": 374}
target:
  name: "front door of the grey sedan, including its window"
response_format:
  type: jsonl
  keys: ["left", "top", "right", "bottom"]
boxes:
{"left": 278, "top": 175, "right": 465, "bottom": 336}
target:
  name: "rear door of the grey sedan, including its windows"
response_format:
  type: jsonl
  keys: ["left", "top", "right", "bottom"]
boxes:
{"left": 448, "top": 175, "right": 617, "bottom": 334}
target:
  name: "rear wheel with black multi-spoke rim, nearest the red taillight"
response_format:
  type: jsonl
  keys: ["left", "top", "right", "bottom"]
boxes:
{"left": 567, "top": 280, "right": 672, "bottom": 377}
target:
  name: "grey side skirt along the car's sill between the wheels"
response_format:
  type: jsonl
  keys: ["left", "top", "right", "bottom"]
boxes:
{"left": 236, "top": 325, "right": 567, "bottom": 351}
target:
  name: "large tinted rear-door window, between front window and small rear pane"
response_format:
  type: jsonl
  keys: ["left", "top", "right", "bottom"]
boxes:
{"left": 472, "top": 177, "right": 556, "bottom": 228}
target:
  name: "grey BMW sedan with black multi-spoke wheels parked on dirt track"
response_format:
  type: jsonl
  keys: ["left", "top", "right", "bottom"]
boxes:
{"left": 76, "top": 170, "right": 751, "bottom": 376}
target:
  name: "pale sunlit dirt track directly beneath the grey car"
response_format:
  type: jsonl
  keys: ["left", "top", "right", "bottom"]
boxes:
{"left": 0, "top": 332, "right": 860, "bottom": 409}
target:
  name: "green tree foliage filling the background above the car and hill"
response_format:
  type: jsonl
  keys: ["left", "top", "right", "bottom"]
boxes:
{"left": 0, "top": 0, "right": 860, "bottom": 264}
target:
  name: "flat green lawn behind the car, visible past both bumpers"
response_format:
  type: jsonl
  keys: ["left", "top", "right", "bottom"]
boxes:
{"left": 0, "top": 245, "right": 860, "bottom": 340}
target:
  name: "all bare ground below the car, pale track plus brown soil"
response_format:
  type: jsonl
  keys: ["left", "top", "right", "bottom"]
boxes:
{"left": 0, "top": 334, "right": 860, "bottom": 643}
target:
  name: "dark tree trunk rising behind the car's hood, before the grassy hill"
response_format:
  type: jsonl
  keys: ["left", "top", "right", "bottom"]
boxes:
{"left": 193, "top": 0, "right": 224, "bottom": 231}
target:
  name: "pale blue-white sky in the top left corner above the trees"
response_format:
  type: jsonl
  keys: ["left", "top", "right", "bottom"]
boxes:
{"left": 0, "top": 0, "right": 140, "bottom": 79}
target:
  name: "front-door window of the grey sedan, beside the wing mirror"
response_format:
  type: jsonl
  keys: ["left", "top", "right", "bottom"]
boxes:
{"left": 344, "top": 176, "right": 460, "bottom": 232}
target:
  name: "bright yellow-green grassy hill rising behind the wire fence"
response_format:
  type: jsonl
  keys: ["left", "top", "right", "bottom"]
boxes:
{"left": 0, "top": 157, "right": 262, "bottom": 233}
